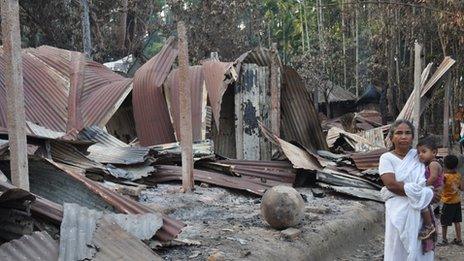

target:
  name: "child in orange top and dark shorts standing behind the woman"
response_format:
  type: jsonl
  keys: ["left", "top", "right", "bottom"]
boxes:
{"left": 440, "top": 155, "right": 464, "bottom": 246}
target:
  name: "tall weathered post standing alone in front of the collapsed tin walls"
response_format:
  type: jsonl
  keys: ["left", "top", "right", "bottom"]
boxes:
{"left": 177, "top": 21, "right": 194, "bottom": 192}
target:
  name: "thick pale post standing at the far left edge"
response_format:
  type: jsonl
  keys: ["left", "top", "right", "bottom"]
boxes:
{"left": 0, "top": 0, "right": 29, "bottom": 190}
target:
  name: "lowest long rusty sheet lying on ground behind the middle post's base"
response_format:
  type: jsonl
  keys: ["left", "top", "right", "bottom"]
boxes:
{"left": 147, "top": 165, "right": 282, "bottom": 196}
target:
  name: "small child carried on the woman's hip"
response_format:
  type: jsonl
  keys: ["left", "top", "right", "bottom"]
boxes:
{"left": 417, "top": 137, "right": 443, "bottom": 240}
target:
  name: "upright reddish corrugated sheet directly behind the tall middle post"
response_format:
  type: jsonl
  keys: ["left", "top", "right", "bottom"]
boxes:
{"left": 164, "top": 65, "right": 207, "bottom": 141}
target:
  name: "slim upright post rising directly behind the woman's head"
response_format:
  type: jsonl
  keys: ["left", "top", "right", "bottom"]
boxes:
{"left": 412, "top": 40, "right": 422, "bottom": 147}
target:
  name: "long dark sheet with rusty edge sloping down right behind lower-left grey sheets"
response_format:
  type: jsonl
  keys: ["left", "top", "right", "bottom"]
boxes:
{"left": 0, "top": 160, "right": 185, "bottom": 240}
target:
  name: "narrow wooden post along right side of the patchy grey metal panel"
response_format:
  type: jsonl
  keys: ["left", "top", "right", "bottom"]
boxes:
{"left": 270, "top": 43, "right": 281, "bottom": 137}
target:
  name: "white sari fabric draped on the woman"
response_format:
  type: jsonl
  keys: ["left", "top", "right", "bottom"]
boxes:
{"left": 380, "top": 149, "right": 434, "bottom": 261}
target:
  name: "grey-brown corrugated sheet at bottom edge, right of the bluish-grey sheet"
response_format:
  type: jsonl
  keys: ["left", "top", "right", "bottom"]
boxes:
{"left": 91, "top": 215, "right": 163, "bottom": 261}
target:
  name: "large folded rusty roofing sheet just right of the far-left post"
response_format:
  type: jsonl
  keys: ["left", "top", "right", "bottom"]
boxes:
{"left": 0, "top": 46, "right": 132, "bottom": 132}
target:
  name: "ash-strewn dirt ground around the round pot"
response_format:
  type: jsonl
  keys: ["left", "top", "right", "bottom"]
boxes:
{"left": 140, "top": 184, "right": 383, "bottom": 260}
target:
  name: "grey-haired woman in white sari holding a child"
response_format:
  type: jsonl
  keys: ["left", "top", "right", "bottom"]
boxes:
{"left": 379, "top": 120, "right": 434, "bottom": 261}
